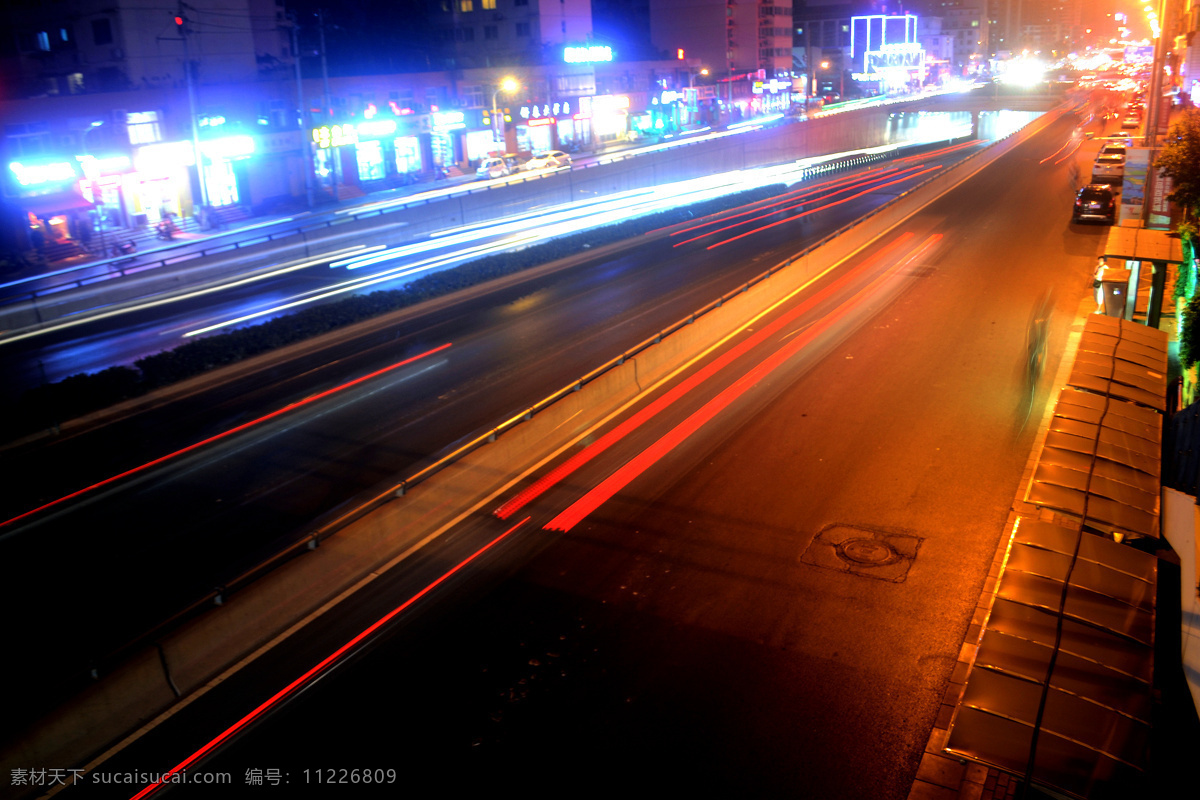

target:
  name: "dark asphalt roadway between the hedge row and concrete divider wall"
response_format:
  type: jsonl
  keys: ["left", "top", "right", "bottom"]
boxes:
{"left": 0, "top": 137, "right": 984, "bottom": 708}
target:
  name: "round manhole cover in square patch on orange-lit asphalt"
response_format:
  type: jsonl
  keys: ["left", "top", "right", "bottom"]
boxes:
{"left": 800, "top": 524, "right": 922, "bottom": 583}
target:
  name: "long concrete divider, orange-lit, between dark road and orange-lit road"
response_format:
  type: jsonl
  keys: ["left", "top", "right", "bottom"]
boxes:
{"left": 0, "top": 101, "right": 1069, "bottom": 796}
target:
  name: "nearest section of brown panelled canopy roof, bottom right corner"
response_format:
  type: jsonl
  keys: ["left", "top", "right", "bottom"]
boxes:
{"left": 946, "top": 518, "right": 1158, "bottom": 798}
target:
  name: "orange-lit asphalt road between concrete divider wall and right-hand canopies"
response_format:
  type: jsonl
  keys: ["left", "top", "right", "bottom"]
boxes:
{"left": 58, "top": 107, "right": 1106, "bottom": 800}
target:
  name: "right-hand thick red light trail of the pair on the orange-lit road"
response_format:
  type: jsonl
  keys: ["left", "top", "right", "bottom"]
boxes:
{"left": 545, "top": 234, "right": 942, "bottom": 533}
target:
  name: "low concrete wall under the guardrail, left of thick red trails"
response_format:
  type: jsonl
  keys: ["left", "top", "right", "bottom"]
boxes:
{"left": 0, "top": 98, "right": 1070, "bottom": 796}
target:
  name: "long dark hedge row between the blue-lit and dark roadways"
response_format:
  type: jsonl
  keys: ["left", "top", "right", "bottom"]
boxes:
{"left": 2, "top": 185, "right": 785, "bottom": 439}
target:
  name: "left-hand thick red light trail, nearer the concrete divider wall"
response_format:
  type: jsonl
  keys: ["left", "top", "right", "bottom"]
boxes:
{"left": 494, "top": 233, "right": 914, "bottom": 519}
